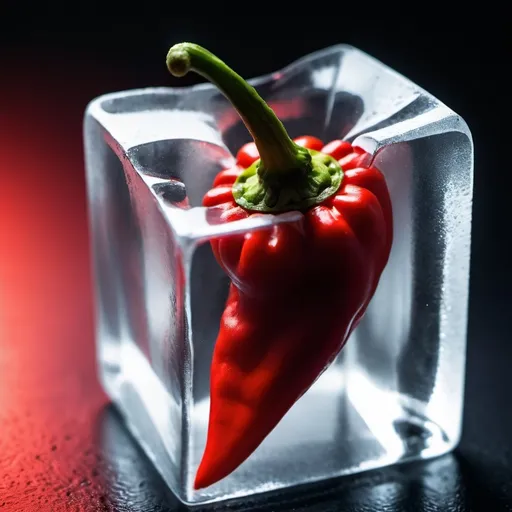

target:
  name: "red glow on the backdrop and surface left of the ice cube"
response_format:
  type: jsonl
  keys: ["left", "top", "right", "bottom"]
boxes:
{"left": 0, "top": 54, "right": 125, "bottom": 512}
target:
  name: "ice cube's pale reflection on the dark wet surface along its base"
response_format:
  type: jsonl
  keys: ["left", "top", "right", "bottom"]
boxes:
{"left": 98, "top": 406, "right": 502, "bottom": 512}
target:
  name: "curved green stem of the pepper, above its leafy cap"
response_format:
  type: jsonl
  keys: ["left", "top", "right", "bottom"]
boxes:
{"left": 167, "top": 43, "right": 301, "bottom": 173}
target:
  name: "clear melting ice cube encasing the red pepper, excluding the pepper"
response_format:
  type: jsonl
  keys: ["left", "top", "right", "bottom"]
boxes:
{"left": 85, "top": 45, "right": 473, "bottom": 505}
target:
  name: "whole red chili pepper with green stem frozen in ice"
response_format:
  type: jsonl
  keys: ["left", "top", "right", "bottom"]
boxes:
{"left": 167, "top": 43, "right": 393, "bottom": 489}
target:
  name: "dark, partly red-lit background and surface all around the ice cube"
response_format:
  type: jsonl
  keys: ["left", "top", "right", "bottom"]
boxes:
{"left": 0, "top": 16, "right": 512, "bottom": 512}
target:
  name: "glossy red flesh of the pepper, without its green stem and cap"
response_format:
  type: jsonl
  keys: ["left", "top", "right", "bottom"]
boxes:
{"left": 195, "top": 137, "right": 393, "bottom": 488}
